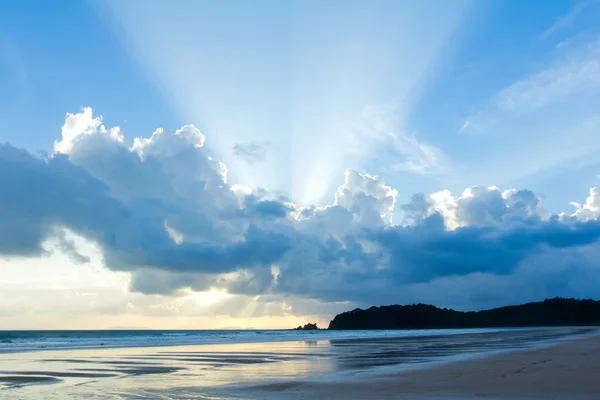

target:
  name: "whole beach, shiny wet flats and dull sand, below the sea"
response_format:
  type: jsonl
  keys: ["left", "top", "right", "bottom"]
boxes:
{"left": 0, "top": 328, "right": 600, "bottom": 400}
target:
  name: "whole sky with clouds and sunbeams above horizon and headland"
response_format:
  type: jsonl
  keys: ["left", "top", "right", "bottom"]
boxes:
{"left": 0, "top": 0, "right": 600, "bottom": 329}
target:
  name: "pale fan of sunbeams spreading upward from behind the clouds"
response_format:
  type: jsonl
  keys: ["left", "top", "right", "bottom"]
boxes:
{"left": 99, "top": 0, "right": 470, "bottom": 205}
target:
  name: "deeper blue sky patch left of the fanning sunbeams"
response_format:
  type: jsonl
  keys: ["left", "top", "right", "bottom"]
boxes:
{"left": 0, "top": 1, "right": 180, "bottom": 151}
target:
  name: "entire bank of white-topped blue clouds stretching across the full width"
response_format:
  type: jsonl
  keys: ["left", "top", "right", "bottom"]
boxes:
{"left": 0, "top": 109, "right": 600, "bottom": 307}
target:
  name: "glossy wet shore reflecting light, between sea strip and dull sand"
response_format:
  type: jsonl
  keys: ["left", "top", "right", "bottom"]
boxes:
{"left": 0, "top": 328, "right": 592, "bottom": 399}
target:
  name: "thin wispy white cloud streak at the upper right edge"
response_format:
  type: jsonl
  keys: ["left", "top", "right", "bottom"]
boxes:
{"left": 457, "top": 34, "right": 600, "bottom": 137}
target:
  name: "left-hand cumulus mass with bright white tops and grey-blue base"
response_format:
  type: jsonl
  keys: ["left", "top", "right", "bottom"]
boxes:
{"left": 0, "top": 110, "right": 288, "bottom": 272}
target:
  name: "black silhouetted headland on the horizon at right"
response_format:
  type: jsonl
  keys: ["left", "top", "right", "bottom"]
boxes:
{"left": 329, "top": 298, "right": 600, "bottom": 329}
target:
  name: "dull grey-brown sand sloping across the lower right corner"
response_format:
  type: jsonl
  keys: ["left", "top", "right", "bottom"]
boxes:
{"left": 243, "top": 336, "right": 600, "bottom": 400}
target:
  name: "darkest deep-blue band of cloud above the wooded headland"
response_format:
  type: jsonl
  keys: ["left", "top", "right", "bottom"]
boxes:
{"left": 376, "top": 214, "right": 600, "bottom": 283}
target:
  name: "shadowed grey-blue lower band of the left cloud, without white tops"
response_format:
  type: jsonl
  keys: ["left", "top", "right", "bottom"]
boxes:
{"left": 0, "top": 144, "right": 289, "bottom": 273}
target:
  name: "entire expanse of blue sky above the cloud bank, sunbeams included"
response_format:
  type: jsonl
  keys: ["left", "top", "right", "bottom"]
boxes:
{"left": 0, "top": 1, "right": 598, "bottom": 211}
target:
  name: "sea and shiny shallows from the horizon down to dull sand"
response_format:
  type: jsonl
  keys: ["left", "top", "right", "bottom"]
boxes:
{"left": 0, "top": 328, "right": 595, "bottom": 400}
